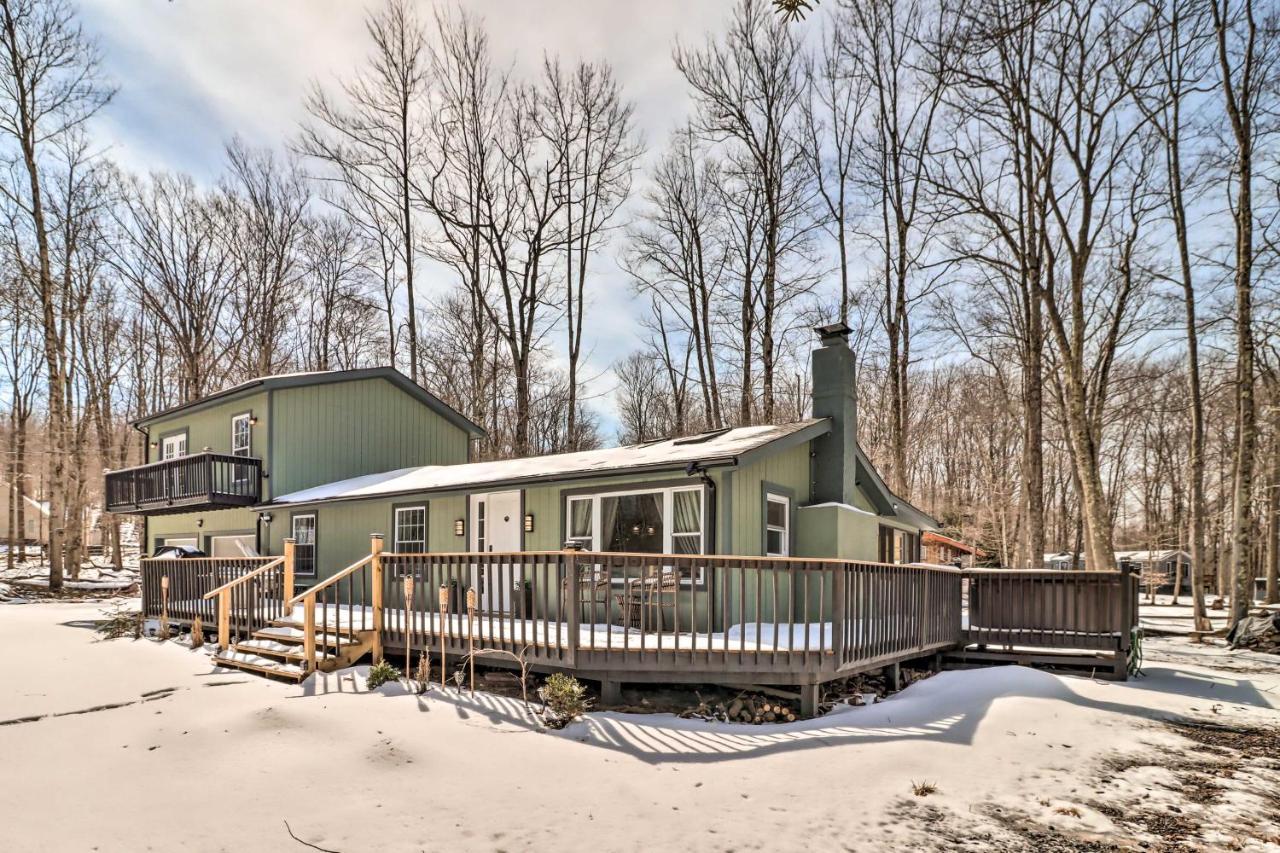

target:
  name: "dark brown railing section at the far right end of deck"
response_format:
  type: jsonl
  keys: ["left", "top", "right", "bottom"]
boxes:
{"left": 964, "top": 567, "right": 1138, "bottom": 651}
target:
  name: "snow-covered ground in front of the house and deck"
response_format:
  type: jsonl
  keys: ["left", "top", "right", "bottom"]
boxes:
{"left": 0, "top": 602, "right": 1280, "bottom": 853}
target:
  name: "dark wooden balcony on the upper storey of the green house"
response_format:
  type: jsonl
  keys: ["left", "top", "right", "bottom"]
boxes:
{"left": 106, "top": 452, "right": 262, "bottom": 515}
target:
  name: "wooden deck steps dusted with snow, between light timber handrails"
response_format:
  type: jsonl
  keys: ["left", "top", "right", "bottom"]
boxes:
{"left": 214, "top": 619, "right": 374, "bottom": 681}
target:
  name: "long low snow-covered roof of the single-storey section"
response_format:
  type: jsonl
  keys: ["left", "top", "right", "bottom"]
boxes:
{"left": 271, "top": 418, "right": 831, "bottom": 503}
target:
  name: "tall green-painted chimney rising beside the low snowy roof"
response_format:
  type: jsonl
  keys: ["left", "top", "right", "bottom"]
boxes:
{"left": 813, "top": 323, "right": 858, "bottom": 503}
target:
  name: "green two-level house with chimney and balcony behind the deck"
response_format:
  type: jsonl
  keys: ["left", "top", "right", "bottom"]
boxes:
{"left": 108, "top": 325, "right": 937, "bottom": 585}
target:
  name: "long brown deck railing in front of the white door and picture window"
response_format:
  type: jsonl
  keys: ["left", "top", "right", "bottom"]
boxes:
{"left": 381, "top": 552, "right": 961, "bottom": 678}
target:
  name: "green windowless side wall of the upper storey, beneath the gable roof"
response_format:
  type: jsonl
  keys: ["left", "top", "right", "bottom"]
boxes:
{"left": 268, "top": 378, "right": 470, "bottom": 494}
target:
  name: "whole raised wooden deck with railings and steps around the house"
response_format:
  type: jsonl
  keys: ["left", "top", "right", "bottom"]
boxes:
{"left": 142, "top": 545, "right": 1137, "bottom": 712}
